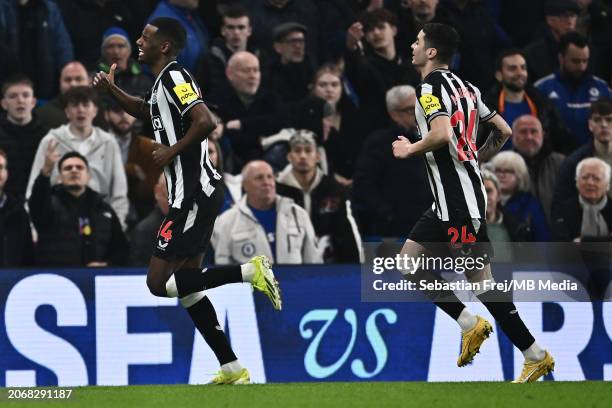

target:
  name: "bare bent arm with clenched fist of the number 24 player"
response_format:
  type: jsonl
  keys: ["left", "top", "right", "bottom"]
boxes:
{"left": 393, "top": 115, "right": 453, "bottom": 159}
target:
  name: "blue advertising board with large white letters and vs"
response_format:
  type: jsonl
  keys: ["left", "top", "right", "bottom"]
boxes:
{"left": 0, "top": 265, "right": 612, "bottom": 386}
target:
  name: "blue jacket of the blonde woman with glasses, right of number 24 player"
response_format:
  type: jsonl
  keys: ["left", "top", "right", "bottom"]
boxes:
{"left": 504, "top": 191, "right": 551, "bottom": 242}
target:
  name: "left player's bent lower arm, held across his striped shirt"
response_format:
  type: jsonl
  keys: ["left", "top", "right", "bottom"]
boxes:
{"left": 153, "top": 103, "right": 217, "bottom": 166}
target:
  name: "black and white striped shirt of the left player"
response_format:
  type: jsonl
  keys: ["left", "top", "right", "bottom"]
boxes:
{"left": 149, "top": 61, "right": 221, "bottom": 208}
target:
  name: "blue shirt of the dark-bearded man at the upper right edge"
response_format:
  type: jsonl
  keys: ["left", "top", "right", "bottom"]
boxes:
{"left": 534, "top": 71, "right": 612, "bottom": 147}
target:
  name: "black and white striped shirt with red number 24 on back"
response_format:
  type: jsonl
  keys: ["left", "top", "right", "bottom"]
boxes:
{"left": 415, "top": 69, "right": 496, "bottom": 221}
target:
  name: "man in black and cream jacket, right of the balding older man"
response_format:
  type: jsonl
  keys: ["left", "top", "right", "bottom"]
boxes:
{"left": 276, "top": 130, "right": 361, "bottom": 263}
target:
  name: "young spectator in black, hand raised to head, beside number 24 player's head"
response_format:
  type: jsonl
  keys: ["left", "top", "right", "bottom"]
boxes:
{"left": 344, "top": 9, "right": 420, "bottom": 131}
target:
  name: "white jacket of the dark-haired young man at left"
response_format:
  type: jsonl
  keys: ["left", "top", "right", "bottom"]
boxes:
{"left": 26, "top": 125, "right": 129, "bottom": 225}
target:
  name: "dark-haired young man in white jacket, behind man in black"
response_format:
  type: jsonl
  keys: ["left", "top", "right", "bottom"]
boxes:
{"left": 26, "top": 87, "right": 129, "bottom": 225}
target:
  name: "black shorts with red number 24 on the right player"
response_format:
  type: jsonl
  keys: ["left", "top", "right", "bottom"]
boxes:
{"left": 410, "top": 208, "right": 494, "bottom": 264}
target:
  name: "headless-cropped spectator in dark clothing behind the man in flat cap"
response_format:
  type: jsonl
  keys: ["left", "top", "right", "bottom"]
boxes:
{"left": 242, "top": 0, "right": 325, "bottom": 66}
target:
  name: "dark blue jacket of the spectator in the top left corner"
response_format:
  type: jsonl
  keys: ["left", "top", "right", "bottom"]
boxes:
{"left": 0, "top": 0, "right": 74, "bottom": 99}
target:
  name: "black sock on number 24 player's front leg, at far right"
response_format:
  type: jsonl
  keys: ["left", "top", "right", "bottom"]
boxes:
{"left": 477, "top": 290, "right": 535, "bottom": 351}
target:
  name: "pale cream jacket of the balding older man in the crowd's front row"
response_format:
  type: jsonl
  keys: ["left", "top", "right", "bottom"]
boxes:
{"left": 211, "top": 195, "right": 323, "bottom": 265}
